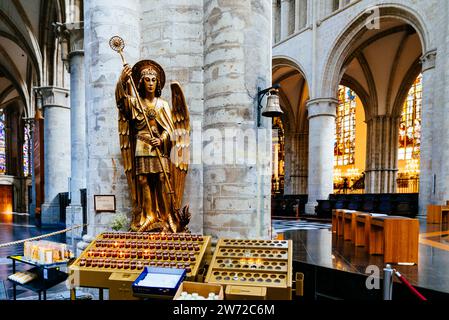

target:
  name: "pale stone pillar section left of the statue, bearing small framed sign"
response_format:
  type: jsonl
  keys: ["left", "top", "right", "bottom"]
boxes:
{"left": 84, "top": 0, "right": 141, "bottom": 236}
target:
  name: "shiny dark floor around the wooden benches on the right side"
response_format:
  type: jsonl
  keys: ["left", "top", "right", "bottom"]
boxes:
{"left": 280, "top": 220, "right": 449, "bottom": 293}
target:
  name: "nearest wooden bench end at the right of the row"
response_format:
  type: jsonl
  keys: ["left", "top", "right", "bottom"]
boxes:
{"left": 369, "top": 216, "right": 419, "bottom": 264}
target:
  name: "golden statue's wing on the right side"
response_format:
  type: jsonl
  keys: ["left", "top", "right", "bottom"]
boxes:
{"left": 170, "top": 82, "right": 190, "bottom": 209}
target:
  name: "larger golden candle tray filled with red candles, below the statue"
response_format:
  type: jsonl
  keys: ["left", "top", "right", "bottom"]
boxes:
{"left": 69, "top": 232, "right": 211, "bottom": 299}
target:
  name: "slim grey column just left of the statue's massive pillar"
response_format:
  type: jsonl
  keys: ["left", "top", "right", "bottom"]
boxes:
{"left": 65, "top": 22, "right": 87, "bottom": 239}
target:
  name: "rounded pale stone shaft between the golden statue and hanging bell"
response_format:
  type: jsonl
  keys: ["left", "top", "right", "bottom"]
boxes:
{"left": 203, "top": 0, "right": 272, "bottom": 238}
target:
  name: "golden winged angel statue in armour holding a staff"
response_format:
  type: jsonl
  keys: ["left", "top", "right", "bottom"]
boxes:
{"left": 115, "top": 60, "right": 190, "bottom": 232}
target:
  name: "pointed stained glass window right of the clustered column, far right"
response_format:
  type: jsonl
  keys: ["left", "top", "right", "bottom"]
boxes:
{"left": 398, "top": 74, "right": 422, "bottom": 160}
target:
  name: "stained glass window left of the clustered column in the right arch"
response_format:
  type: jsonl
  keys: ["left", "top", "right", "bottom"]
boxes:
{"left": 334, "top": 86, "right": 356, "bottom": 166}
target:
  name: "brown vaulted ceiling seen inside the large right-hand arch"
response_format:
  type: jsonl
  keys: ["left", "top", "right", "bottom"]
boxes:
{"left": 342, "top": 19, "right": 422, "bottom": 118}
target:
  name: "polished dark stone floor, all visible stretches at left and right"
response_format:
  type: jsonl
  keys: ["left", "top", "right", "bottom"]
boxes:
{"left": 0, "top": 212, "right": 449, "bottom": 300}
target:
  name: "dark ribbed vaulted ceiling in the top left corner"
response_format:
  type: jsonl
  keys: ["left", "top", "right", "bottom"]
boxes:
{"left": 0, "top": 0, "right": 68, "bottom": 115}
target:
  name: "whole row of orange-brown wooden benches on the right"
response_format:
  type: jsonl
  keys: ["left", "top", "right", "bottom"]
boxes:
{"left": 332, "top": 209, "right": 419, "bottom": 264}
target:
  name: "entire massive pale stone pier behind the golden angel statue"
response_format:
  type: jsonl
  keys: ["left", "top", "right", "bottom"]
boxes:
{"left": 84, "top": 0, "right": 271, "bottom": 238}
